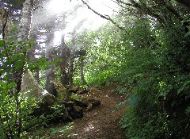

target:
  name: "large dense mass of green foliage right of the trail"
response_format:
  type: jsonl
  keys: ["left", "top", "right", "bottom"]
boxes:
{"left": 76, "top": 4, "right": 190, "bottom": 139}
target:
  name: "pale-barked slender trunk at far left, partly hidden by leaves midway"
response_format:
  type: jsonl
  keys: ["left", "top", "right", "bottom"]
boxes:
{"left": 14, "top": 0, "right": 33, "bottom": 138}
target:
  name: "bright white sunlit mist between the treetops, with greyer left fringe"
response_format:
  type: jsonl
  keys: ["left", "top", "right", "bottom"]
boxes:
{"left": 32, "top": 0, "right": 117, "bottom": 53}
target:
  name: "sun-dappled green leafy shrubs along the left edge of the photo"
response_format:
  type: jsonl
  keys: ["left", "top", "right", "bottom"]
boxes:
{"left": 0, "top": 41, "right": 40, "bottom": 138}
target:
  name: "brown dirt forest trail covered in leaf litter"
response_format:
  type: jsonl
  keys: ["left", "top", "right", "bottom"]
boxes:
{"left": 52, "top": 88, "right": 125, "bottom": 139}
